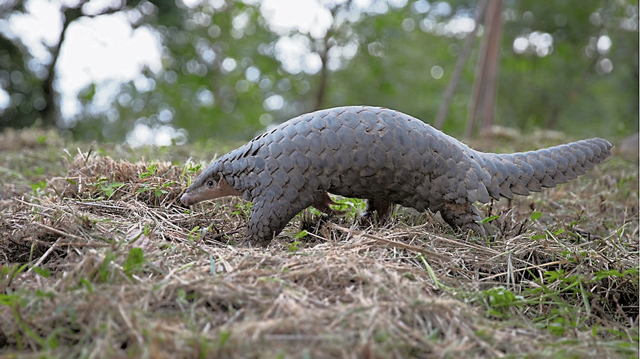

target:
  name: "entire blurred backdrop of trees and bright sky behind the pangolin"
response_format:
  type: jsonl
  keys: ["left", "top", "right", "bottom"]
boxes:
{"left": 0, "top": 0, "right": 639, "bottom": 147}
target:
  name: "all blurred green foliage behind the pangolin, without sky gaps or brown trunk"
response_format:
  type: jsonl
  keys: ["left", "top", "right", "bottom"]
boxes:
{"left": 0, "top": 0, "right": 638, "bottom": 142}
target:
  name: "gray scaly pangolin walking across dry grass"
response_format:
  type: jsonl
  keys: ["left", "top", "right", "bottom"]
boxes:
{"left": 181, "top": 106, "right": 611, "bottom": 244}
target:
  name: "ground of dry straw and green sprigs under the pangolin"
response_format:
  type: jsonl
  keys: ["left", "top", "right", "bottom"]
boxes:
{"left": 0, "top": 130, "right": 639, "bottom": 358}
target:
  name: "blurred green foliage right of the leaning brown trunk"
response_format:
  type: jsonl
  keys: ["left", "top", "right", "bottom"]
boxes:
{"left": 499, "top": 0, "right": 638, "bottom": 136}
